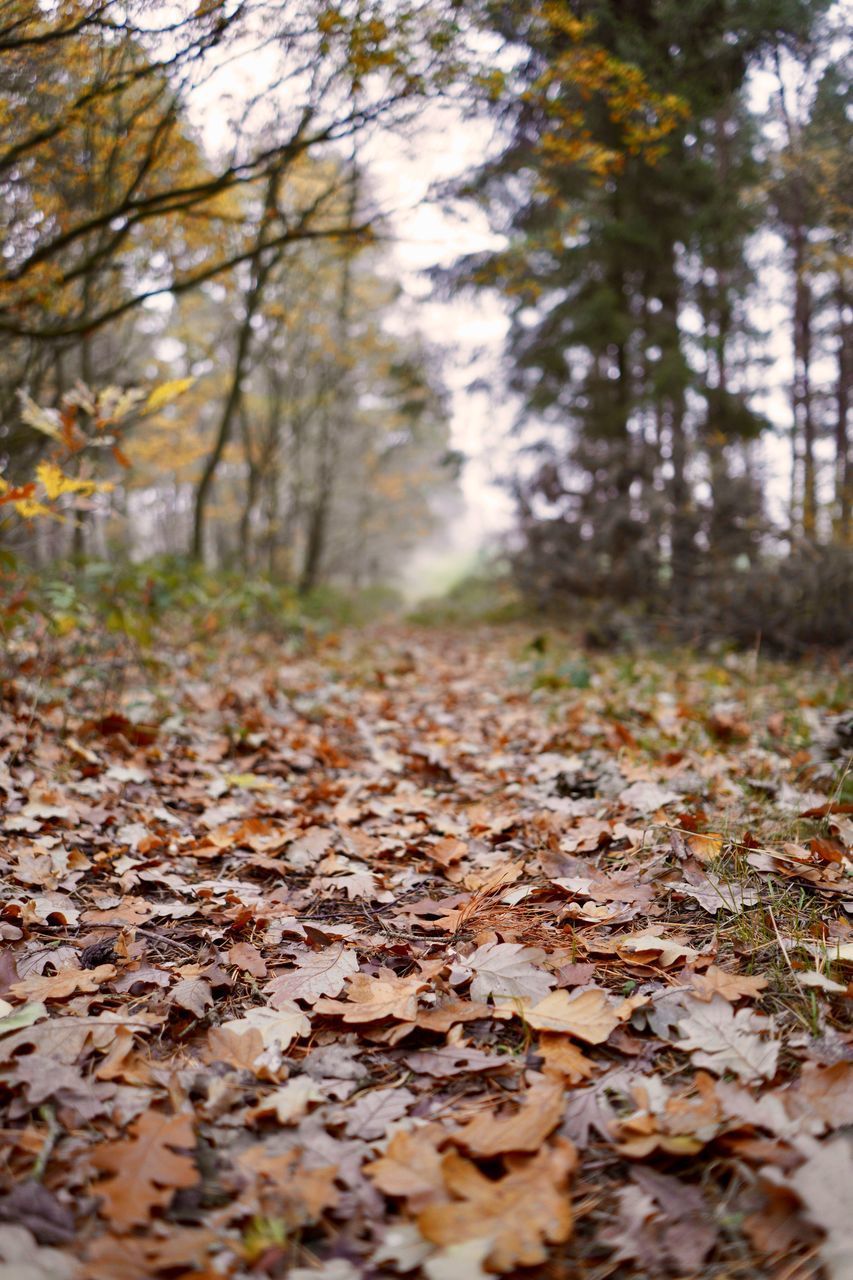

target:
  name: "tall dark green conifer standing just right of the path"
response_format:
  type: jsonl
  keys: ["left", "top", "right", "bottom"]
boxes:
{"left": 456, "top": 0, "right": 820, "bottom": 612}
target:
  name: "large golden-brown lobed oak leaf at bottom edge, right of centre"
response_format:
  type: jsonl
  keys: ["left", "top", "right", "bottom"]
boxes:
{"left": 418, "top": 1139, "right": 576, "bottom": 1271}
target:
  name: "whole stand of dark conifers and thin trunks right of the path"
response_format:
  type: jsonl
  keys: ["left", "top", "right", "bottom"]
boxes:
{"left": 451, "top": 0, "right": 853, "bottom": 643}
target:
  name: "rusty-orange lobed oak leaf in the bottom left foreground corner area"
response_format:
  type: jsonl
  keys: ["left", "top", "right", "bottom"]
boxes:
{"left": 91, "top": 1111, "right": 199, "bottom": 1231}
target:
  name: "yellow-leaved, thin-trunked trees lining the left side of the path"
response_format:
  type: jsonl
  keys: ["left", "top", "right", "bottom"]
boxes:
{"left": 0, "top": 0, "right": 460, "bottom": 590}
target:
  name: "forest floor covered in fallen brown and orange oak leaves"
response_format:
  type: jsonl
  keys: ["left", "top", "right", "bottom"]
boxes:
{"left": 0, "top": 627, "right": 853, "bottom": 1280}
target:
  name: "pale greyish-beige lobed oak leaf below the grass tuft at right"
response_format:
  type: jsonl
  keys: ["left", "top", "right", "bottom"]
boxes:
{"left": 675, "top": 996, "right": 779, "bottom": 1082}
